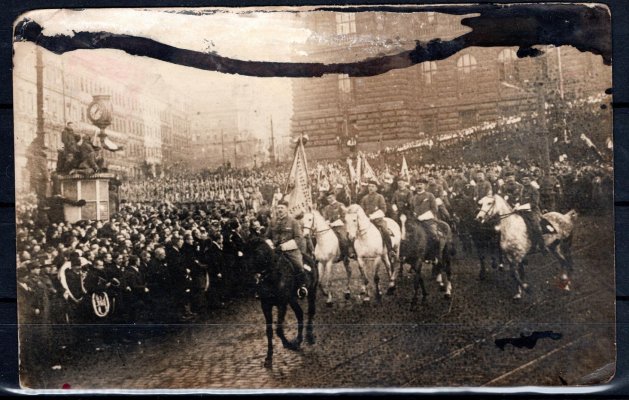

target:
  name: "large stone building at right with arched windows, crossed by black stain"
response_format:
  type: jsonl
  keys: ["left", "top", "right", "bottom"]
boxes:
{"left": 292, "top": 12, "right": 611, "bottom": 158}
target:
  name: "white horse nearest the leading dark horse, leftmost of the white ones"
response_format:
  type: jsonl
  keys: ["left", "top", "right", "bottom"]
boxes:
{"left": 302, "top": 210, "right": 352, "bottom": 307}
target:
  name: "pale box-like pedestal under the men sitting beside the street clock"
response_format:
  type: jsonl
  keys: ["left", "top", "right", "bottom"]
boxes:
{"left": 60, "top": 173, "right": 114, "bottom": 223}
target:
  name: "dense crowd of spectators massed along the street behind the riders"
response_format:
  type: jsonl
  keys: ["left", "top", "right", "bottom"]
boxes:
{"left": 16, "top": 122, "right": 613, "bottom": 376}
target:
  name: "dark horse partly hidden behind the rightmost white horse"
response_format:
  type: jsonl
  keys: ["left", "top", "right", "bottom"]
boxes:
{"left": 450, "top": 194, "right": 503, "bottom": 280}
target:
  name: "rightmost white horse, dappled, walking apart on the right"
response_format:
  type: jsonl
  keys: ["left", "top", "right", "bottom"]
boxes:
{"left": 476, "top": 195, "right": 577, "bottom": 299}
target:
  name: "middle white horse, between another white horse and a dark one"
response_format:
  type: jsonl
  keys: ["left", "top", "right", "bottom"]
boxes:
{"left": 345, "top": 204, "right": 402, "bottom": 302}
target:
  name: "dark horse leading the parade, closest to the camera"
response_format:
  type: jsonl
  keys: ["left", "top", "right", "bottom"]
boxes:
{"left": 246, "top": 237, "right": 319, "bottom": 368}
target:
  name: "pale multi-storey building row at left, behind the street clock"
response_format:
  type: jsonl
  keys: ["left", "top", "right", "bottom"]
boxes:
{"left": 13, "top": 44, "right": 191, "bottom": 190}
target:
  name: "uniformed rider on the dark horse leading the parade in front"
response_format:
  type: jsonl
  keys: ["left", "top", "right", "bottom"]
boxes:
{"left": 269, "top": 200, "right": 309, "bottom": 298}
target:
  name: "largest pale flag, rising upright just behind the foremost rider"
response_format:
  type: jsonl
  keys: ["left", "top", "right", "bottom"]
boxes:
{"left": 285, "top": 140, "right": 312, "bottom": 215}
